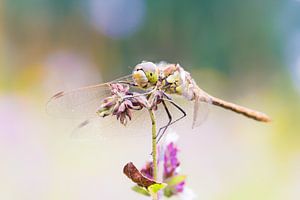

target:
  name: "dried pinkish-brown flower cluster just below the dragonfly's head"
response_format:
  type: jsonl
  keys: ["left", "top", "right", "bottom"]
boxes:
{"left": 97, "top": 83, "right": 149, "bottom": 125}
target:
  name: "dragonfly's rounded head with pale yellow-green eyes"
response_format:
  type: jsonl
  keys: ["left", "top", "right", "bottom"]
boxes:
{"left": 132, "top": 62, "right": 159, "bottom": 88}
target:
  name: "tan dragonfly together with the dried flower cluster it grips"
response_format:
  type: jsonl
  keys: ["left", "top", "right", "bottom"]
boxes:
{"left": 47, "top": 61, "right": 271, "bottom": 141}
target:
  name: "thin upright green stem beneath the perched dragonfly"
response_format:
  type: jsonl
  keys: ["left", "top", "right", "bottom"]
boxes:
{"left": 149, "top": 109, "right": 158, "bottom": 200}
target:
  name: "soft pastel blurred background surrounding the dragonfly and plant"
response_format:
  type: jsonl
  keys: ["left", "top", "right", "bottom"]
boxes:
{"left": 0, "top": 0, "right": 300, "bottom": 200}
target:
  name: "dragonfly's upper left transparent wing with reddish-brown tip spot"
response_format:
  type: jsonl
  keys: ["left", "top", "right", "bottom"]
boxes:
{"left": 46, "top": 75, "right": 132, "bottom": 119}
